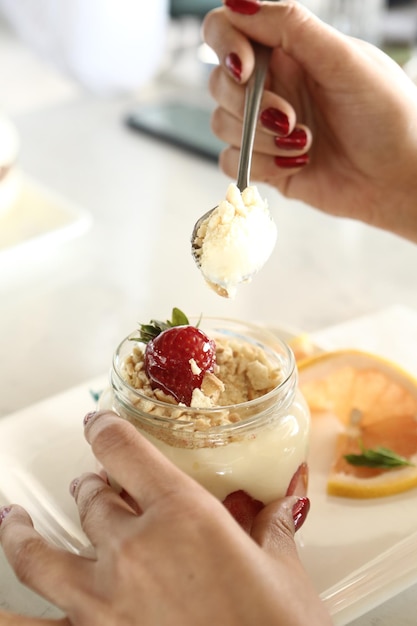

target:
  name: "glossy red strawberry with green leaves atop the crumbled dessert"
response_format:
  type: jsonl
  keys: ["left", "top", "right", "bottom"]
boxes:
{"left": 135, "top": 309, "right": 216, "bottom": 406}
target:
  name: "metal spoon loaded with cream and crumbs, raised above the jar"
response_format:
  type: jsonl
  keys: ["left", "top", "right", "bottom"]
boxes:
{"left": 191, "top": 44, "right": 277, "bottom": 298}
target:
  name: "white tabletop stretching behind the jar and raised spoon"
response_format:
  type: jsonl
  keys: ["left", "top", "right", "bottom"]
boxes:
{"left": 0, "top": 14, "right": 417, "bottom": 626}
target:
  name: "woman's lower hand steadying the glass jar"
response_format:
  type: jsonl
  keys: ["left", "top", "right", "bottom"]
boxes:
{"left": 0, "top": 412, "right": 331, "bottom": 626}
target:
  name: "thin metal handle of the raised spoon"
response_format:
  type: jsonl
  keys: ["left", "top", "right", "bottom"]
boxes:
{"left": 236, "top": 42, "right": 271, "bottom": 192}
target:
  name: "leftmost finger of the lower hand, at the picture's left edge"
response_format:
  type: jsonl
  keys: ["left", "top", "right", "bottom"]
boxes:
{"left": 0, "top": 505, "right": 91, "bottom": 610}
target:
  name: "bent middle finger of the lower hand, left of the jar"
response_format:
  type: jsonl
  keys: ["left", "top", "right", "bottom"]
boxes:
{"left": 71, "top": 473, "right": 141, "bottom": 547}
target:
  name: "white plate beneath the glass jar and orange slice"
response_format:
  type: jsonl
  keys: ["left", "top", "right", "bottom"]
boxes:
{"left": 0, "top": 309, "right": 417, "bottom": 626}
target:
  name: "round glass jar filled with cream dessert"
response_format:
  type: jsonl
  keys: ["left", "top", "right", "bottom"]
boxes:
{"left": 100, "top": 318, "right": 310, "bottom": 504}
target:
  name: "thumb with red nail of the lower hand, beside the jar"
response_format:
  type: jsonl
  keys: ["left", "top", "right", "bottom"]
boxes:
{"left": 251, "top": 496, "right": 310, "bottom": 556}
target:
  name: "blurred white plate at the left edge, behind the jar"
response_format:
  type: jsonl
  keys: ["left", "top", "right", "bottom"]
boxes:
{"left": 0, "top": 173, "right": 91, "bottom": 262}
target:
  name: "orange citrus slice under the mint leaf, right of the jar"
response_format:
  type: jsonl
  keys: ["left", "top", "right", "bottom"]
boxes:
{"left": 298, "top": 350, "right": 417, "bottom": 498}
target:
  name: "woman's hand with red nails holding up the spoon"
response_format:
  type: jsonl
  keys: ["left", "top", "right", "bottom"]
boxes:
{"left": 204, "top": 0, "right": 417, "bottom": 241}
